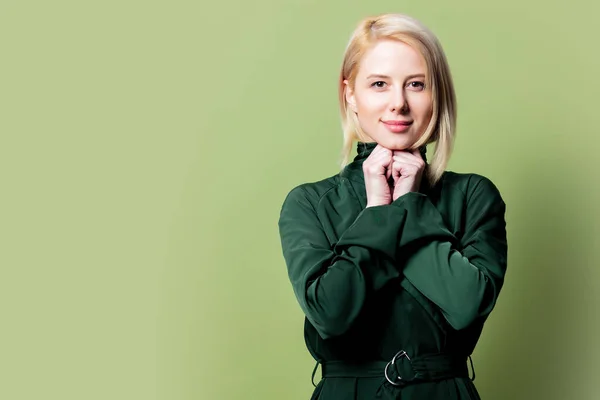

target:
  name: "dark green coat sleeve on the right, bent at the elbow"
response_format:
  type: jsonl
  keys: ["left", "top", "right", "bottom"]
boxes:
{"left": 392, "top": 177, "right": 507, "bottom": 330}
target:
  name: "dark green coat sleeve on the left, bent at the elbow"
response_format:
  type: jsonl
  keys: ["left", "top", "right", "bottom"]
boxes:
{"left": 279, "top": 187, "right": 414, "bottom": 339}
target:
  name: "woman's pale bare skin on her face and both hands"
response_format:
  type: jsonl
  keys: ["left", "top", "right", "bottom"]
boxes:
{"left": 344, "top": 39, "right": 433, "bottom": 207}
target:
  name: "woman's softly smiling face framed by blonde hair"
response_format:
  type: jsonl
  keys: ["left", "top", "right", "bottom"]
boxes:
{"left": 344, "top": 40, "right": 433, "bottom": 150}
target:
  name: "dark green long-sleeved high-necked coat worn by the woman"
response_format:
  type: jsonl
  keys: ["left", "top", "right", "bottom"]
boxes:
{"left": 279, "top": 143, "right": 507, "bottom": 400}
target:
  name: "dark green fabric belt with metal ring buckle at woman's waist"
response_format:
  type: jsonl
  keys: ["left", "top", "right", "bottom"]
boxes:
{"left": 313, "top": 350, "right": 475, "bottom": 386}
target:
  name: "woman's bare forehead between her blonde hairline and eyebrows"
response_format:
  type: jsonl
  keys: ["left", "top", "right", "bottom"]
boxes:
{"left": 358, "top": 39, "right": 427, "bottom": 77}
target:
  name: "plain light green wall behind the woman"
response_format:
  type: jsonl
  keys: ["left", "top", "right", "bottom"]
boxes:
{"left": 0, "top": 0, "right": 600, "bottom": 400}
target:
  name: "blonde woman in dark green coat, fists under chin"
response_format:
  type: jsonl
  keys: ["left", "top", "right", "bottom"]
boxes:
{"left": 279, "top": 14, "right": 507, "bottom": 400}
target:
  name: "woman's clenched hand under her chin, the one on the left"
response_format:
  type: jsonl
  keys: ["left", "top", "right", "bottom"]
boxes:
{"left": 363, "top": 144, "right": 393, "bottom": 207}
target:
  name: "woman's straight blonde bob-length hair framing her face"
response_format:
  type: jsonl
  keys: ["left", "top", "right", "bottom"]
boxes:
{"left": 338, "top": 14, "right": 456, "bottom": 184}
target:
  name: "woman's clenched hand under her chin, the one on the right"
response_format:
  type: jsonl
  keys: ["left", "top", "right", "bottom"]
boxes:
{"left": 391, "top": 149, "right": 425, "bottom": 201}
